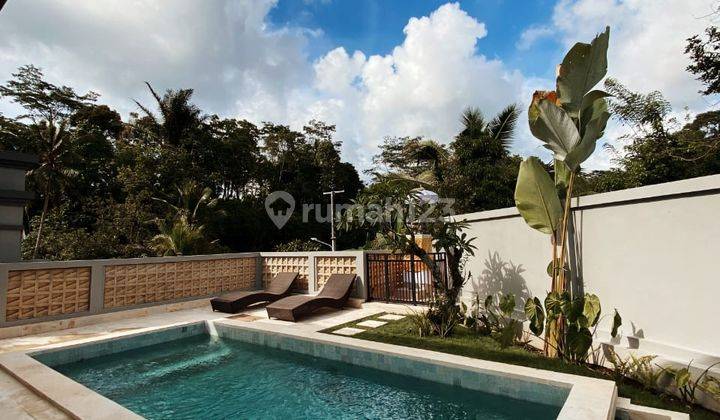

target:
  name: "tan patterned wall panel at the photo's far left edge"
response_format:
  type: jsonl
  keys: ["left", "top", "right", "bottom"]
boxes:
{"left": 5, "top": 267, "right": 91, "bottom": 321}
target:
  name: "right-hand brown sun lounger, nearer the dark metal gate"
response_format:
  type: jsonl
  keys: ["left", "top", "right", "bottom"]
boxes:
{"left": 265, "top": 274, "right": 355, "bottom": 322}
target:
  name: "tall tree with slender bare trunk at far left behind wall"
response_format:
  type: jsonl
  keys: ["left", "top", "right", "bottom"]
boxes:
{"left": 0, "top": 65, "right": 97, "bottom": 258}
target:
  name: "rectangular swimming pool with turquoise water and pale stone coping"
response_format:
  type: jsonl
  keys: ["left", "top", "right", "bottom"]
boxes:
{"left": 16, "top": 322, "right": 614, "bottom": 419}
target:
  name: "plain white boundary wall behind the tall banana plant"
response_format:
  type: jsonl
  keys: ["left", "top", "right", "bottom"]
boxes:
{"left": 457, "top": 175, "right": 720, "bottom": 365}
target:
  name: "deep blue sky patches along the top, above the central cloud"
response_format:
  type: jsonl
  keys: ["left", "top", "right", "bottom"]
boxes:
{"left": 268, "top": 0, "right": 560, "bottom": 77}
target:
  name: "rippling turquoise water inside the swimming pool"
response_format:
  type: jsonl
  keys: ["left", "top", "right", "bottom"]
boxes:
{"left": 53, "top": 334, "right": 560, "bottom": 419}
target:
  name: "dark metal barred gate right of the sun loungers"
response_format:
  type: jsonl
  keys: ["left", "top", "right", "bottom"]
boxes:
{"left": 366, "top": 252, "right": 447, "bottom": 305}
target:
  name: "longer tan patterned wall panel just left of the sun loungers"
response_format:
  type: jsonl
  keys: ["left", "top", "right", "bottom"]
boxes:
{"left": 103, "top": 257, "right": 256, "bottom": 308}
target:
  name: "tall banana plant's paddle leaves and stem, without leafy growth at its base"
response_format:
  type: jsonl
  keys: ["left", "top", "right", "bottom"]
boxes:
{"left": 515, "top": 27, "right": 610, "bottom": 355}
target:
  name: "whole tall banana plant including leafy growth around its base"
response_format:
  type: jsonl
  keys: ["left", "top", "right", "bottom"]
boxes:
{"left": 515, "top": 27, "right": 610, "bottom": 361}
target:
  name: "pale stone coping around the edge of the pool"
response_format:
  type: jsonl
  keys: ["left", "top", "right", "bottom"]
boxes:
{"left": 0, "top": 319, "right": 617, "bottom": 420}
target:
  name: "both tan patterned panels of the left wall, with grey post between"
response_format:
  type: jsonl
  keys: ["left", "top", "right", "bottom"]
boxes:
{"left": 0, "top": 253, "right": 262, "bottom": 327}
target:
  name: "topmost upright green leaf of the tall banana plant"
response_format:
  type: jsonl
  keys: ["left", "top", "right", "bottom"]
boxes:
{"left": 557, "top": 27, "right": 610, "bottom": 118}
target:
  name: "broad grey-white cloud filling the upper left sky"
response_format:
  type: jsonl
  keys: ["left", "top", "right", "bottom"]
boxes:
{"left": 0, "top": 0, "right": 317, "bottom": 121}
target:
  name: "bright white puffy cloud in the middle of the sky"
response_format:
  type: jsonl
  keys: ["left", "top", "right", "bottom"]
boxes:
{"left": 302, "top": 3, "right": 522, "bottom": 167}
